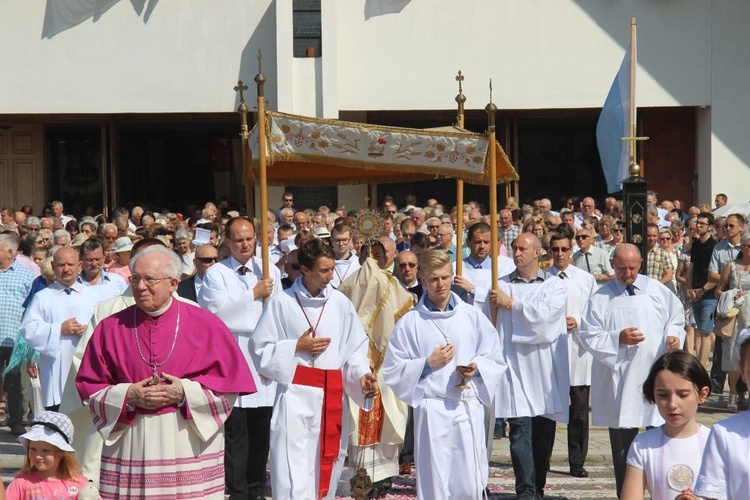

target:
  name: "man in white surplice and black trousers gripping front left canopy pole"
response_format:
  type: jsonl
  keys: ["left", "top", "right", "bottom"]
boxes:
{"left": 198, "top": 217, "right": 281, "bottom": 499}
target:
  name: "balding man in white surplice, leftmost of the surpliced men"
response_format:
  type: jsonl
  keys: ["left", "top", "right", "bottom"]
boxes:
{"left": 21, "top": 247, "right": 102, "bottom": 411}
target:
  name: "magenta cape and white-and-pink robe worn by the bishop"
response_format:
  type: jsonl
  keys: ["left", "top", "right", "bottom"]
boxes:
{"left": 76, "top": 300, "right": 256, "bottom": 499}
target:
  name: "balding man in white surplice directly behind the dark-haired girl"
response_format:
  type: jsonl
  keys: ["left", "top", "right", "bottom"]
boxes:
{"left": 581, "top": 243, "right": 685, "bottom": 497}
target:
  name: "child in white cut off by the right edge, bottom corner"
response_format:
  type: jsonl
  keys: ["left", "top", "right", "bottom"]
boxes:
{"left": 695, "top": 328, "right": 750, "bottom": 500}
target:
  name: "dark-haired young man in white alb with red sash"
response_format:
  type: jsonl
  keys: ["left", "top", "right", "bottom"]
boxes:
{"left": 251, "top": 238, "right": 378, "bottom": 499}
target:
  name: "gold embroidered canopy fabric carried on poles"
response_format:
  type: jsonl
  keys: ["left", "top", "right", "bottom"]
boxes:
{"left": 249, "top": 111, "right": 518, "bottom": 185}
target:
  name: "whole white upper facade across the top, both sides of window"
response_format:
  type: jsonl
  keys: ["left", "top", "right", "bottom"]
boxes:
{"left": 0, "top": 0, "right": 716, "bottom": 116}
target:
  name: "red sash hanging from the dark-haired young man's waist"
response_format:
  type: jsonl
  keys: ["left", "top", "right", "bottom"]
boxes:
{"left": 292, "top": 365, "right": 344, "bottom": 498}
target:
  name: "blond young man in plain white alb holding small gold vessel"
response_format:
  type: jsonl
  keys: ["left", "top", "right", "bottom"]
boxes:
{"left": 381, "top": 250, "right": 505, "bottom": 500}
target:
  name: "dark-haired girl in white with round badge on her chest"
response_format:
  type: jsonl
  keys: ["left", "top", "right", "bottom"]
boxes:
{"left": 621, "top": 350, "right": 711, "bottom": 500}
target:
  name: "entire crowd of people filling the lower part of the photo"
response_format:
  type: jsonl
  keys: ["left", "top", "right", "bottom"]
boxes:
{"left": 0, "top": 188, "right": 750, "bottom": 499}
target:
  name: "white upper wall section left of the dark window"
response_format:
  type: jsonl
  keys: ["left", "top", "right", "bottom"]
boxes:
{"left": 0, "top": 0, "right": 276, "bottom": 113}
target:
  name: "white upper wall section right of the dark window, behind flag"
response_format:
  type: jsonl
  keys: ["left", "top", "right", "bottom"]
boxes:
{"left": 338, "top": 0, "right": 712, "bottom": 110}
